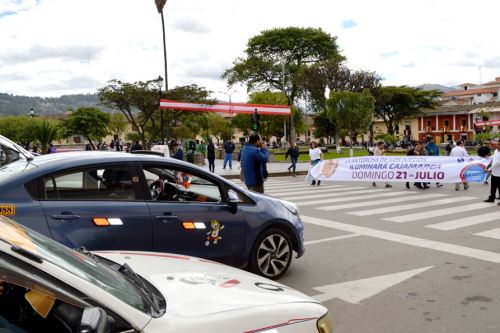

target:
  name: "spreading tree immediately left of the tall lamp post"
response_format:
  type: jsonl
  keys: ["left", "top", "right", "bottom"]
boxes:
{"left": 98, "top": 80, "right": 164, "bottom": 145}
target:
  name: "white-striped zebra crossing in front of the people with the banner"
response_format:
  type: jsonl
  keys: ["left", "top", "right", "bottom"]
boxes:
{"left": 229, "top": 178, "right": 500, "bottom": 240}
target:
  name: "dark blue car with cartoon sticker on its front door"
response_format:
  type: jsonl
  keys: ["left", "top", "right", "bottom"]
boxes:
{"left": 0, "top": 139, "right": 304, "bottom": 279}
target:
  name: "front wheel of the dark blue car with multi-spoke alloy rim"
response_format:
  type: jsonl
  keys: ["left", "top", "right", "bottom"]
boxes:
{"left": 248, "top": 228, "right": 293, "bottom": 280}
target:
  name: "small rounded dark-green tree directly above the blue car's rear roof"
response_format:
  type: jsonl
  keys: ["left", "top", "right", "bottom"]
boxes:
{"left": 63, "top": 107, "right": 110, "bottom": 149}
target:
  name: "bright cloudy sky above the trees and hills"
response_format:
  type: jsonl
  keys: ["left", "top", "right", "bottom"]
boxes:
{"left": 0, "top": 0, "right": 500, "bottom": 101}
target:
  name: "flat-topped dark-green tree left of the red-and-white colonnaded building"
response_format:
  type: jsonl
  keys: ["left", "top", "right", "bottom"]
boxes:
{"left": 372, "top": 86, "right": 442, "bottom": 135}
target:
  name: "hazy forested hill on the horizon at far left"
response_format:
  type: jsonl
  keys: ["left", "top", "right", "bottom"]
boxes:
{"left": 0, "top": 93, "right": 112, "bottom": 116}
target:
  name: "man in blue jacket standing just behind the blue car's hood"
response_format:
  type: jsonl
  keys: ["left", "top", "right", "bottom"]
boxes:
{"left": 241, "top": 134, "right": 269, "bottom": 193}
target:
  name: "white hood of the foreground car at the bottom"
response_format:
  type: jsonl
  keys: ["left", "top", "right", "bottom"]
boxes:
{"left": 95, "top": 251, "right": 317, "bottom": 316}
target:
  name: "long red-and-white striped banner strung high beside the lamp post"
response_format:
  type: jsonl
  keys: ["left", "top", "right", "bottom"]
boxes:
{"left": 160, "top": 99, "right": 290, "bottom": 116}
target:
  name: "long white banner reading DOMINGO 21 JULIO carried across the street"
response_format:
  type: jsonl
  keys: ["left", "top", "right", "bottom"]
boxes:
{"left": 309, "top": 156, "right": 489, "bottom": 183}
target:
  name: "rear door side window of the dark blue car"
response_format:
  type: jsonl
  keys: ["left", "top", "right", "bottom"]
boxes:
{"left": 43, "top": 166, "right": 136, "bottom": 200}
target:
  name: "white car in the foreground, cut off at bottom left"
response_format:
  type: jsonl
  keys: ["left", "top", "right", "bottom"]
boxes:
{"left": 0, "top": 215, "right": 333, "bottom": 333}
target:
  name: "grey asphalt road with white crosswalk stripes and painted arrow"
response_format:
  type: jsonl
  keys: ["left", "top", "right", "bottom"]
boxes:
{"left": 230, "top": 177, "right": 500, "bottom": 333}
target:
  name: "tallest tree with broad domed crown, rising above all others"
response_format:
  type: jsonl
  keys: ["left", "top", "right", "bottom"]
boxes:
{"left": 222, "top": 27, "right": 339, "bottom": 141}
